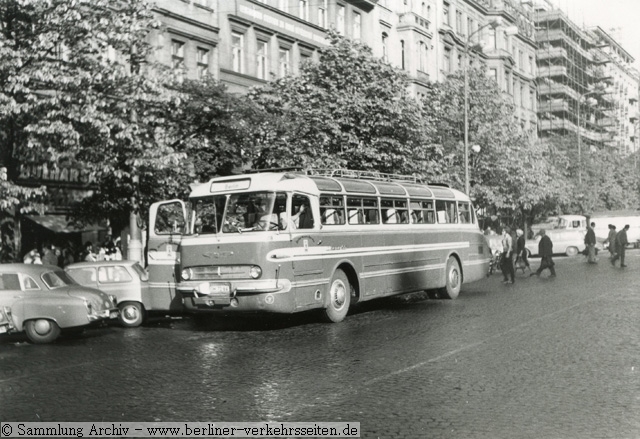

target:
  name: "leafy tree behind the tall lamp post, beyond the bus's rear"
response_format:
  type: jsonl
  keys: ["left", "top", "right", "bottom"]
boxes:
{"left": 423, "top": 69, "right": 560, "bottom": 230}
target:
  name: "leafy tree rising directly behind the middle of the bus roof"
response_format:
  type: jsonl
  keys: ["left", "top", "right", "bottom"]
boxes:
{"left": 250, "top": 32, "right": 440, "bottom": 177}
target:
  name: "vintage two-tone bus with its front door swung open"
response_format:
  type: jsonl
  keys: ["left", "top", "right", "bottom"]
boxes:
{"left": 148, "top": 170, "right": 491, "bottom": 322}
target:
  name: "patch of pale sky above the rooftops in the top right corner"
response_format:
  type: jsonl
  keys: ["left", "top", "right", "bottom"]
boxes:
{"left": 552, "top": 0, "right": 640, "bottom": 69}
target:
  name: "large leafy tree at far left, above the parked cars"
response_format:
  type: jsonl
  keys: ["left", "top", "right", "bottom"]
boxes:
{"left": 0, "top": 0, "right": 183, "bottom": 234}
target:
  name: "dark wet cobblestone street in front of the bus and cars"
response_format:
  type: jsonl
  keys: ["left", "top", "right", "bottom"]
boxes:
{"left": 0, "top": 250, "right": 640, "bottom": 439}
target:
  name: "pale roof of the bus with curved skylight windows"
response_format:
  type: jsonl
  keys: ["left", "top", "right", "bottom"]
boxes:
{"left": 190, "top": 172, "right": 469, "bottom": 201}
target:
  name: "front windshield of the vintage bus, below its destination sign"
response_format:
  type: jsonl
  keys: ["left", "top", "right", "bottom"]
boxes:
{"left": 194, "top": 192, "right": 287, "bottom": 234}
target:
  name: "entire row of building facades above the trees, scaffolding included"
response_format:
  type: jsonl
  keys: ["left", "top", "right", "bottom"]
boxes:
{"left": 145, "top": 0, "right": 640, "bottom": 153}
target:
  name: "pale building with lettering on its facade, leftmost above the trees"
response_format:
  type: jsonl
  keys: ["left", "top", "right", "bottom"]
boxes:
{"left": 151, "top": 0, "right": 376, "bottom": 93}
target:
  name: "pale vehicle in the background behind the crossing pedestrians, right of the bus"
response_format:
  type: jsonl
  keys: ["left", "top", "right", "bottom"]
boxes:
{"left": 525, "top": 215, "right": 587, "bottom": 256}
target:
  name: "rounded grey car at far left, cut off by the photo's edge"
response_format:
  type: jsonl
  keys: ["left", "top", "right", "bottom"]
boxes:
{"left": 0, "top": 264, "right": 118, "bottom": 343}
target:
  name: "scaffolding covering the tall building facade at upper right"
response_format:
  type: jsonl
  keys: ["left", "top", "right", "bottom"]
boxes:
{"left": 535, "top": 8, "right": 615, "bottom": 148}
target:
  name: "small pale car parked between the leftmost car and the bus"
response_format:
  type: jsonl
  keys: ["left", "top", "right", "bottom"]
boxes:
{"left": 65, "top": 260, "right": 149, "bottom": 327}
